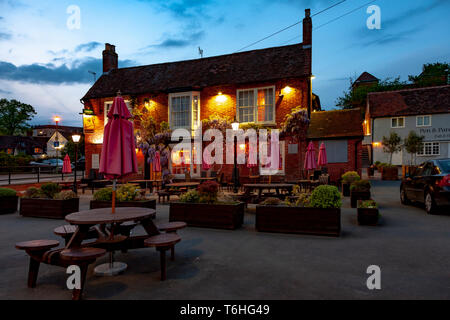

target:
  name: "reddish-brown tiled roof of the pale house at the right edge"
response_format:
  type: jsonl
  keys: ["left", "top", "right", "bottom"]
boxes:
{"left": 368, "top": 85, "right": 450, "bottom": 118}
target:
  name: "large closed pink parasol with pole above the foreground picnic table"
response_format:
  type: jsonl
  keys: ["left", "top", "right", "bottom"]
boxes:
{"left": 99, "top": 93, "right": 138, "bottom": 213}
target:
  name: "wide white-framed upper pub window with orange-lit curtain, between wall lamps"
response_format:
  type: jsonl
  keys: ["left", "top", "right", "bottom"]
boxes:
{"left": 236, "top": 87, "right": 276, "bottom": 123}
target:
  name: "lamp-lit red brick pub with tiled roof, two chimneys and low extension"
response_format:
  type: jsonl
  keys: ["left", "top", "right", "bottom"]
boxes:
{"left": 81, "top": 9, "right": 363, "bottom": 182}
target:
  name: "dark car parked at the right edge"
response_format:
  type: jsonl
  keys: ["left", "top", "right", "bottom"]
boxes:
{"left": 400, "top": 158, "right": 450, "bottom": 214}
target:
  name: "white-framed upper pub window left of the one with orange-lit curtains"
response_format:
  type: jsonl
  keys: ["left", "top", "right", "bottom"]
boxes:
{"left": 169, "top": 92, "right": 200, "bottom": 130}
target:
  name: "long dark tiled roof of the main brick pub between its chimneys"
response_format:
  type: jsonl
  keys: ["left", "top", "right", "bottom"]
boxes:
{"left": 83, "top": 44, "right": 311, "bottom": 100}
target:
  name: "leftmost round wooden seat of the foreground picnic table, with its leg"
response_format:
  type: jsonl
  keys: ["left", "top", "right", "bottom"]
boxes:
{"left": 16, "top": 240, "right": 59, "bottom": 288}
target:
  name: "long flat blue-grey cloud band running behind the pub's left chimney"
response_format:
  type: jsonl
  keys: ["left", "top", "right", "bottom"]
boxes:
{"left": 0, "top": 58, "right": 135, "bottom": 84}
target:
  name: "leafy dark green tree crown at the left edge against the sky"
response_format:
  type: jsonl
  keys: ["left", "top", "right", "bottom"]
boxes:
{"left": 0, "top": 99, "right": 36, "bottom": 136}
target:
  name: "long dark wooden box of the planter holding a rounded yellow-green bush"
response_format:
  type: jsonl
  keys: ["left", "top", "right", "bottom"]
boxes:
{"left": 256, "top": 206, "right": 341, "bottom": 237}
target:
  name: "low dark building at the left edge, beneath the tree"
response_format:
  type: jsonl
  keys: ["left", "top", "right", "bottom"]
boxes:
{"left": 0, "top": 136, "right": 45, "bottom": 157}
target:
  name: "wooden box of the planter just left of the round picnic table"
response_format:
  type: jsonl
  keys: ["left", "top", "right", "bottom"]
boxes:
{"left": 20, "top": 198, "right": 80, "bottom": 219}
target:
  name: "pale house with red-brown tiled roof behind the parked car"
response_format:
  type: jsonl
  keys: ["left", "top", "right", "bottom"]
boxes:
{"left": 364, "top": 85, "right": 450, "bottom": 165}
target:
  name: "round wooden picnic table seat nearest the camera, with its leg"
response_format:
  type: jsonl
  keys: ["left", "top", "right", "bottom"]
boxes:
{"left": 60, "top": 248, "right": 106, "bottom": 301}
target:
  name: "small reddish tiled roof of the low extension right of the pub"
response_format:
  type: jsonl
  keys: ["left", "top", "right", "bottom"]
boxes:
{"left": 308, "top": 108, "right": 364, "bottom": 139}
